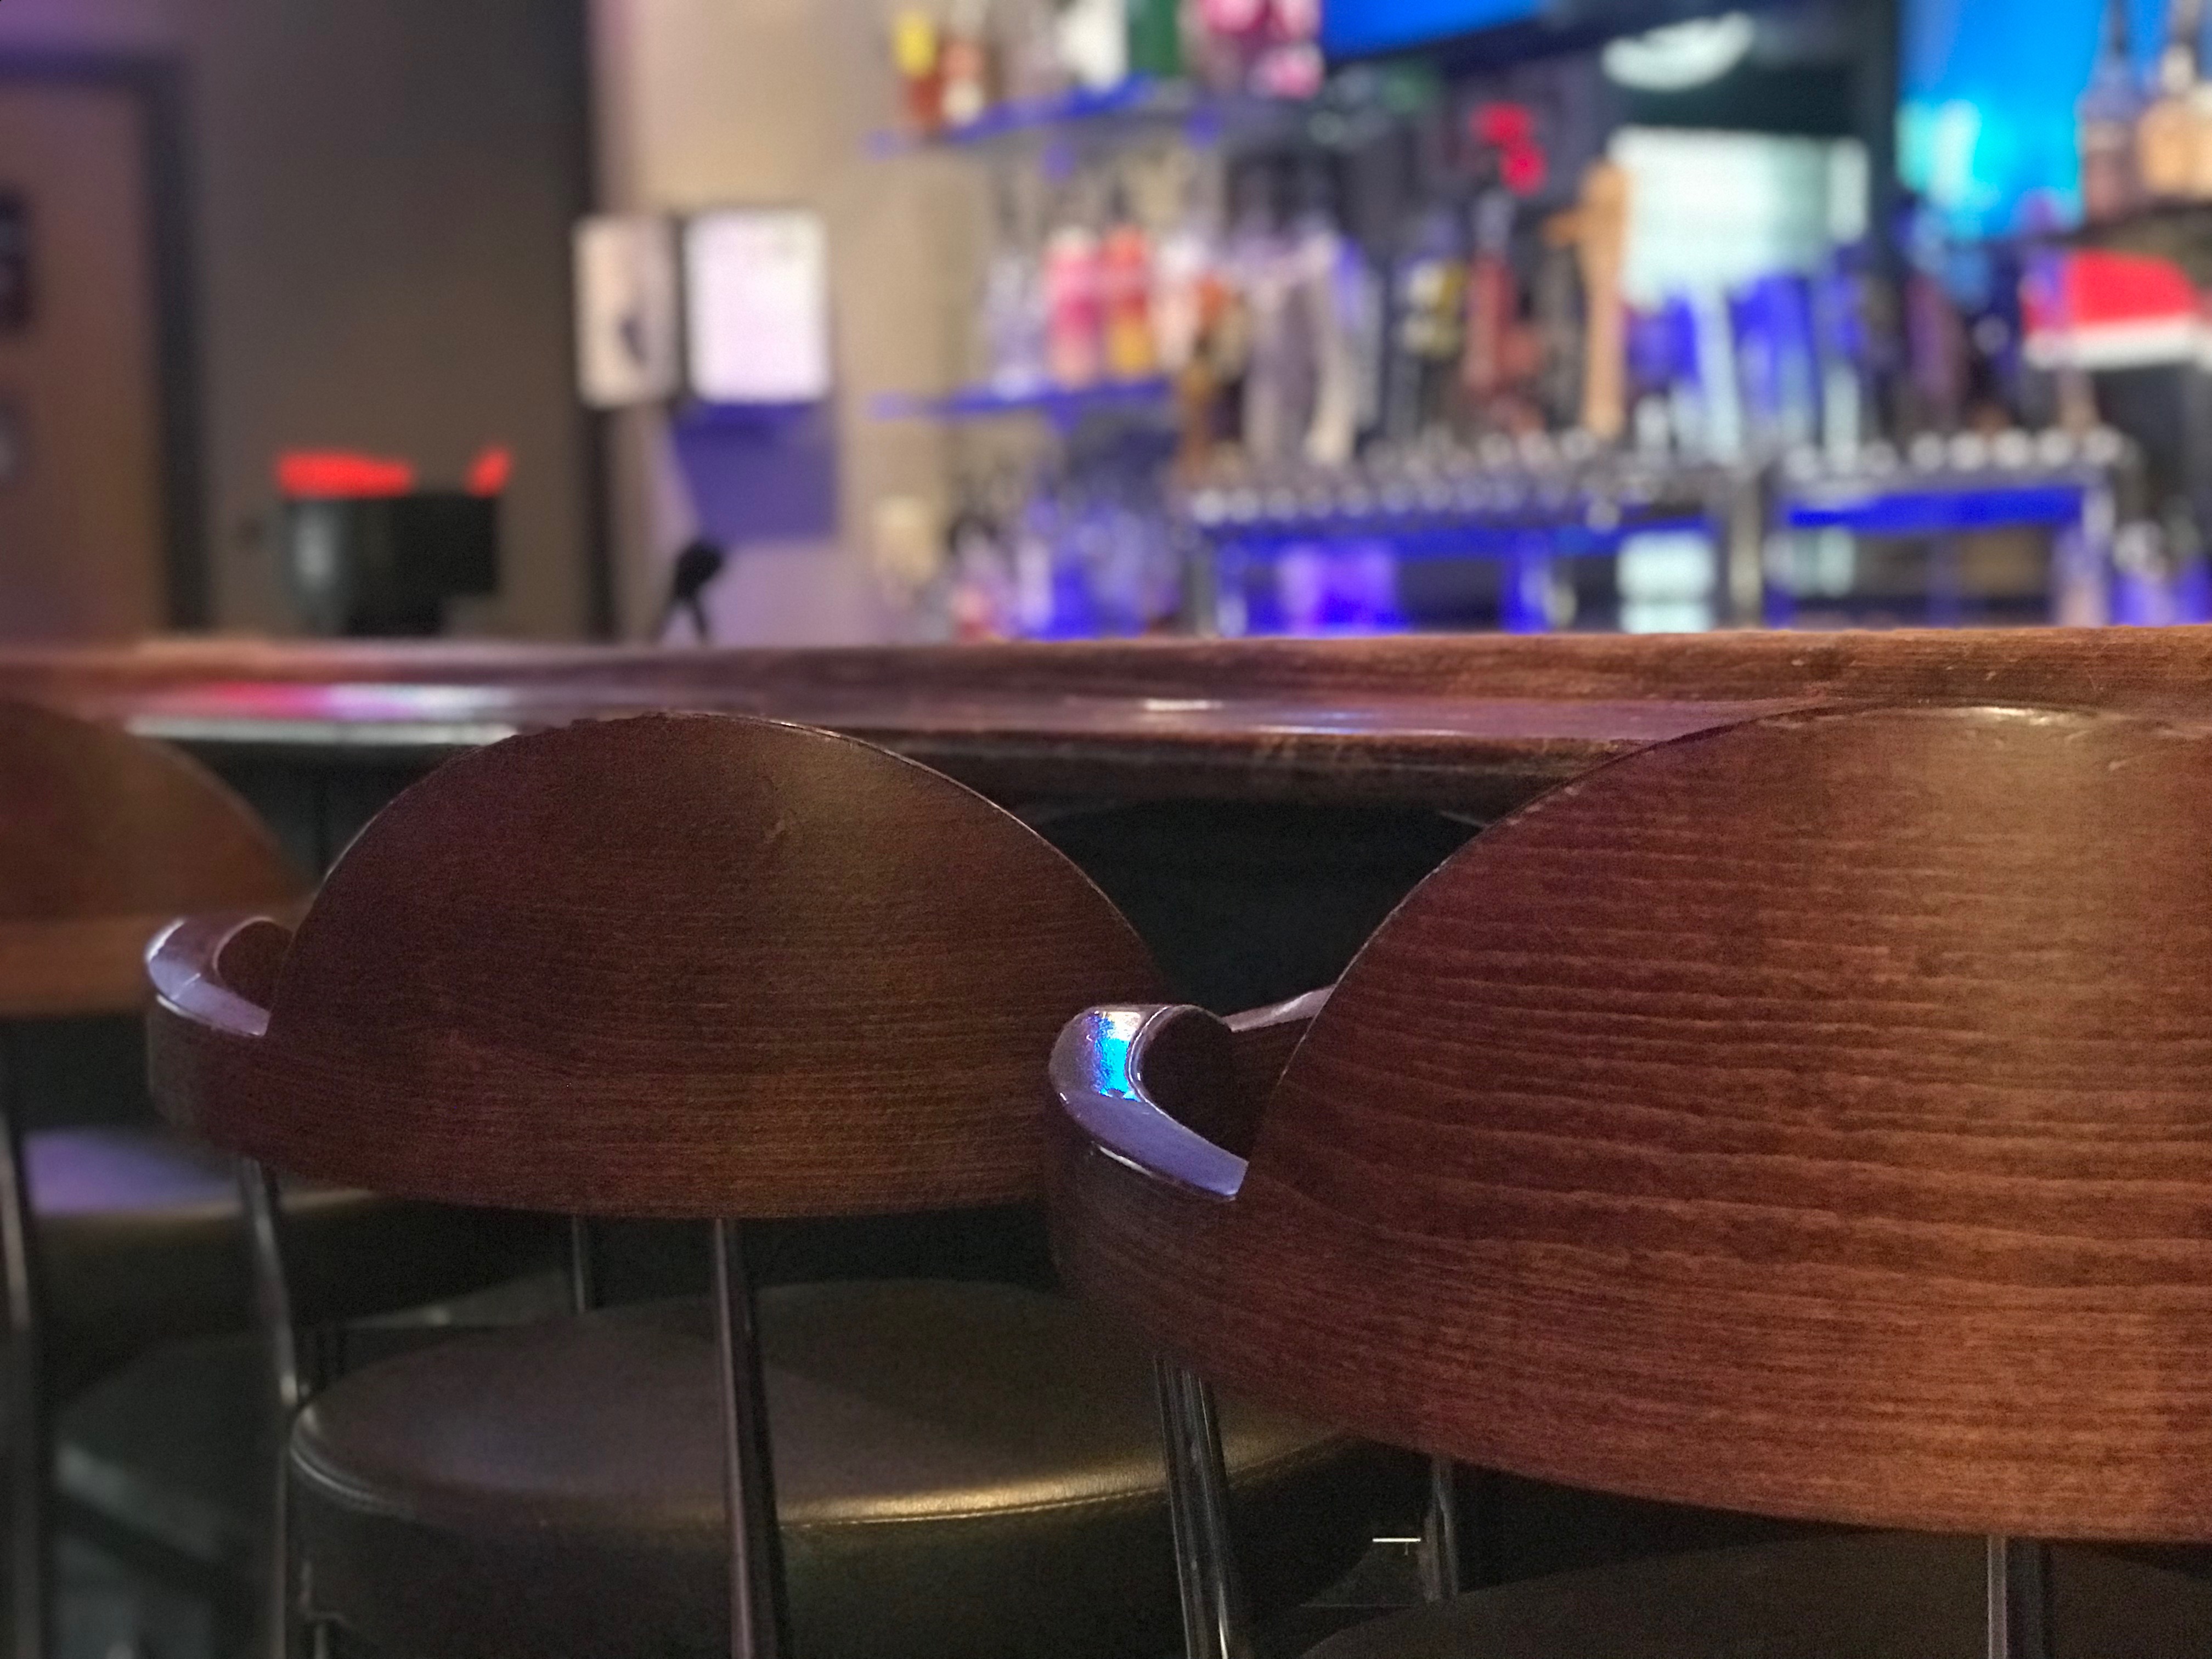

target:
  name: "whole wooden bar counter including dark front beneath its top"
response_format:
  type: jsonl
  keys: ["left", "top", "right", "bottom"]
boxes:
{"left": 0, "top": 628, "right": 2212, "bottom": 1007}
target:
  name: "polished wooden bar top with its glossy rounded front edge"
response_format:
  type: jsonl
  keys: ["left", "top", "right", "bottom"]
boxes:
{"left": 13, "top": 628, "right": 2212, "bottom": 816}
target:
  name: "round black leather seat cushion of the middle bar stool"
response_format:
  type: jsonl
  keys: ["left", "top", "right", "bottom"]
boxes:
{"left": 292, "top": 1283, "right": 1407, "bottom": 1659}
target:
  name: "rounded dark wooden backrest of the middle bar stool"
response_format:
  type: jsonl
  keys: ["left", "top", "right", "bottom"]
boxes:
{"left": 150, "top": 714, "right": 1157, "bottom": 1217}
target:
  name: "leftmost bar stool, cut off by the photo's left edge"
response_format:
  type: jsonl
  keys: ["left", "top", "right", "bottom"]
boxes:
{"left": 0, "top": 703, "right": 548, "bottom": 1655}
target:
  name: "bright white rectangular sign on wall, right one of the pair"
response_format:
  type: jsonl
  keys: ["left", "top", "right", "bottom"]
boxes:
{"left": 684, "top": 208, "right": 830, "bottom": 403}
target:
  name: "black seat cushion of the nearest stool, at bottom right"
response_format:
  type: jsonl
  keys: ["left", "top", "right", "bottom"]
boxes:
{"left": 1307, "top": 1533, "right": 2212, "bottom": 1659}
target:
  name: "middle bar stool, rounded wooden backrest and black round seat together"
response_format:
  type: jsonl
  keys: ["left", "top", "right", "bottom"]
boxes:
{"left": 150, "top": 716, "right": 1393, "bottom": 1659}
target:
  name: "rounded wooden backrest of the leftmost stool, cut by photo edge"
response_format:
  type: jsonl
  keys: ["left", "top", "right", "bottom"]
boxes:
{"left": 0, "top": 703, "right": 305, "bottom": 1018}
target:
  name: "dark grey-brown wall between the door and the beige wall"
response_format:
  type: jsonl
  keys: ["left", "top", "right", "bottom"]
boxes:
{"left": 0, "top": 0, "right": 595, "bottom": 637}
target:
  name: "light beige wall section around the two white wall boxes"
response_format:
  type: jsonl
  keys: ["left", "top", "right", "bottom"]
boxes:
{"left": 593, "top": 0, "right": 978, "bottom": 644}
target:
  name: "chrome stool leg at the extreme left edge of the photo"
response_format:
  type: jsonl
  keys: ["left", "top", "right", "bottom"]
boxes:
{"left": 0, "top": 1035, "right": 53, "bottom": 1659}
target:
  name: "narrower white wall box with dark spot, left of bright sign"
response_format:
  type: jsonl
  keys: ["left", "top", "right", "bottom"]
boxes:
{"left": 575, "top": 215, "right": 684, "bottom": 409}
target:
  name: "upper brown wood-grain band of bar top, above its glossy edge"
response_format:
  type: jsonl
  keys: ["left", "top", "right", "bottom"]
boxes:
{"left": 30, "top": 628, "right": 2212, "bottom": 712}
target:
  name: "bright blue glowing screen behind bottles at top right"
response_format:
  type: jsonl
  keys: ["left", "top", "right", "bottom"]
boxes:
{"left": 1898, "top": 0, "right": 2165, "bottom": 236}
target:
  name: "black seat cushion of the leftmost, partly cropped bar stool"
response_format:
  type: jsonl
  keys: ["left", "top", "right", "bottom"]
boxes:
{"left": 24, "top": 1124, "right": 560, "bottom": 1391}
